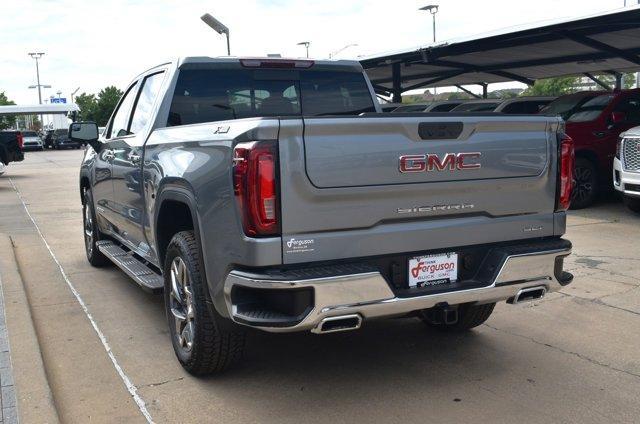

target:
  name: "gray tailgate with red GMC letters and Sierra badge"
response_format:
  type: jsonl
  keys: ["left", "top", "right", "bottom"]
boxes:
{"left": 280, "top": 115, "right": 560, "bottom": 263}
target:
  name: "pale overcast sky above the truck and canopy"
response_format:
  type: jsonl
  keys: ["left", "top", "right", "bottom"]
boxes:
{"left": 0, "top": 0, "right": 635, "bottom": 104}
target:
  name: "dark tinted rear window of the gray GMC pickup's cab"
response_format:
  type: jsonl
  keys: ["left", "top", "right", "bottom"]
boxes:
{"left": 168, "top": 69, "right": 375, "bottom": 126}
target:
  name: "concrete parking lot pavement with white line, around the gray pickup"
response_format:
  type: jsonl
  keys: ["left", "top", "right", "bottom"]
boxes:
{"left": 0, "top": 150, "right": 640, "bottom": 423}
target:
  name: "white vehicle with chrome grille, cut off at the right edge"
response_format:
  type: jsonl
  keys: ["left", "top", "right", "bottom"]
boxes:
{"left": 613, "top": 127, "right": 640, "bottom": 213}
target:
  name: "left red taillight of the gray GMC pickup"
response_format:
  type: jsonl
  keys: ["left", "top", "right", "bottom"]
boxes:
{"left": 233, "top": 141, "right": 280, "bottom": 237}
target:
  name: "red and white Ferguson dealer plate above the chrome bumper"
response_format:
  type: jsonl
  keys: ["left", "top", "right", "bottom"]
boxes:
{"left": 409, "top": 253, "right": 458, "bottom": 287}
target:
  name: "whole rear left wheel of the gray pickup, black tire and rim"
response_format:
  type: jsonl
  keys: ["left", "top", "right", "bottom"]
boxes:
{"left": 164, "top": 231, "right": 245, "bottom": 375}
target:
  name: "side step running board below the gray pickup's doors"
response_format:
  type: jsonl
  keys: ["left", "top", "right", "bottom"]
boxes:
{"left": 96, "top": 240, "right": 164, "bottom": 294}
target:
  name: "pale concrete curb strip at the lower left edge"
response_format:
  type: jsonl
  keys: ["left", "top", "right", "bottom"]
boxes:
{"left": 0, "top": 234, "right": 60, "bottom": 424}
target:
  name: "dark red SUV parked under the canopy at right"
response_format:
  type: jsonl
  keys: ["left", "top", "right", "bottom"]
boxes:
{"left": 540, "top": 89, "right": 640, "bottom": 209}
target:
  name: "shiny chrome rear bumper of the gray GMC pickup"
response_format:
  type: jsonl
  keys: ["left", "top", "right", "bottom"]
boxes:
{"left": 224, "top": 248, "right": 571, "bottom": 332}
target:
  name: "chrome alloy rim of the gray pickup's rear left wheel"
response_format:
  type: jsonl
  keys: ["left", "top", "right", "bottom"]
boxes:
{"left": 169, "top": 256, "right": 195, "bottom": 352}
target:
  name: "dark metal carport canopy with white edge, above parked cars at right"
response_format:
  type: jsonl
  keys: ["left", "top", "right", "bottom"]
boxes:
{"left": 360, "top": 6, "right": 640, "bottom": 100}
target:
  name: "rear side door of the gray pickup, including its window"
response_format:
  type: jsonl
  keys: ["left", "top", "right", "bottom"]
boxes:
{"left": 112, "top": 71, "right": 164, "bottom": 257}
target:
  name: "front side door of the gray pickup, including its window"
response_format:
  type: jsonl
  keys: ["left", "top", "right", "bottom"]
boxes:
{"left": 92, "top": 81, "right": 139, "bottom": 233}
